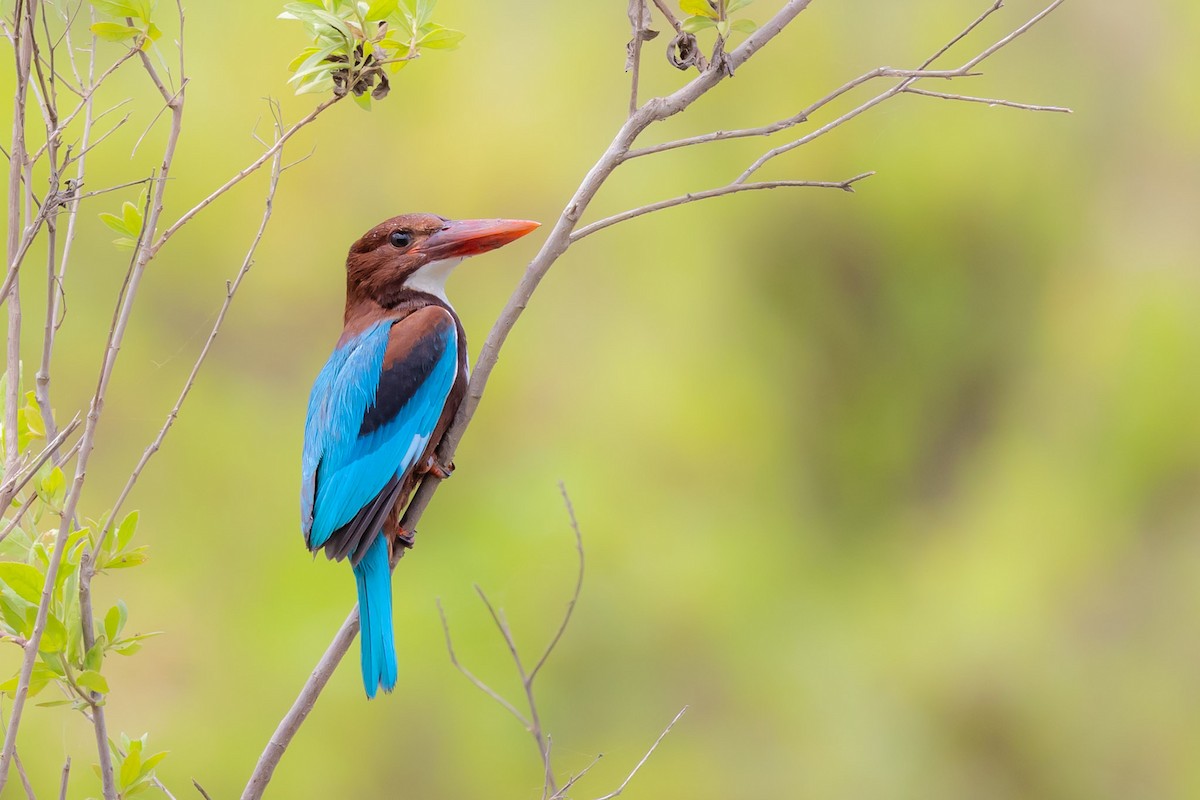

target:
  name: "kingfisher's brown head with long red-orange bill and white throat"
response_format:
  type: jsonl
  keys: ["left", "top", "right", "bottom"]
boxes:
{"left": 346, "top": 213, "right": 540, "bottom": 312}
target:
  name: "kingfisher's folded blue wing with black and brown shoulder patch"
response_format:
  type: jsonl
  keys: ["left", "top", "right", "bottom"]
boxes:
{"left": 300, "top": 306, "right": 458, "bottom": 560}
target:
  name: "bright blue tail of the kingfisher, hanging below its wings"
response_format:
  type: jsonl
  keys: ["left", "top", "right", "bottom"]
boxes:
{"left": 354, "top": 534, "right": 396, "bottom": 698}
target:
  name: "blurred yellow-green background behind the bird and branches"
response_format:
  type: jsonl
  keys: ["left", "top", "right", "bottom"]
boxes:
{"left": 0, "top": 0, "right": 1200, "bottom": 800}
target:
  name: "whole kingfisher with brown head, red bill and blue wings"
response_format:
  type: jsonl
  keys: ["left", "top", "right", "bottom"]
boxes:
{"left": 300, "top": 213, "right": 539, "bottom": 699}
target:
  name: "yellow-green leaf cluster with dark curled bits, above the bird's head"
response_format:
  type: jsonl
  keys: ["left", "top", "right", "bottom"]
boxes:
{"left": 280, "top": 0, "right": 463, "bottom": 110}
